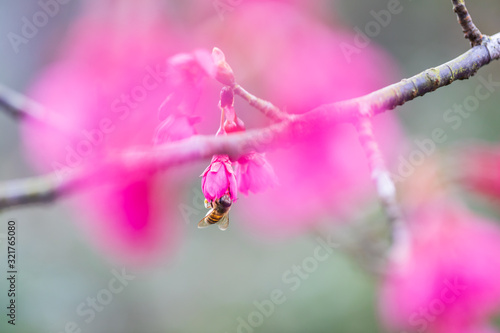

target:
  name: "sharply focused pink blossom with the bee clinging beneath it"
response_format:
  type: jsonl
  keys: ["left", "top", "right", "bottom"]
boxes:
{"left": 200, "top": 155, "right": 238, "bottom": 202}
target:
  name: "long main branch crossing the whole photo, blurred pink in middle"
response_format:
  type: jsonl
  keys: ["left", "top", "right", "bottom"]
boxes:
{"left": 0, "top": 33, "right": 500, "bottom": 208}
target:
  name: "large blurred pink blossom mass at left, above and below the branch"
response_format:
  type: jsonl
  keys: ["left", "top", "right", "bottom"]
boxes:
{"left": 23, "top": 0, "right": 184, "bottom": 264}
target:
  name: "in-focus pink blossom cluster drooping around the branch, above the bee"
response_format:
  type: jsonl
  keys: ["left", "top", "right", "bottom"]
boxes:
{"left": 154, "top": 48, "right": 277, "bottom": 203}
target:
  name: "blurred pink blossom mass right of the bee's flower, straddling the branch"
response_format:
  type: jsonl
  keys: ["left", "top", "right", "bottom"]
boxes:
{"left": 194, "top": 2, "right": 403, "bottom": 237}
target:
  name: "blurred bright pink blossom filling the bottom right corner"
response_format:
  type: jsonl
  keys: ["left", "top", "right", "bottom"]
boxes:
{"left": 380, "top": 201, "right": 500, "bottom": 333}
